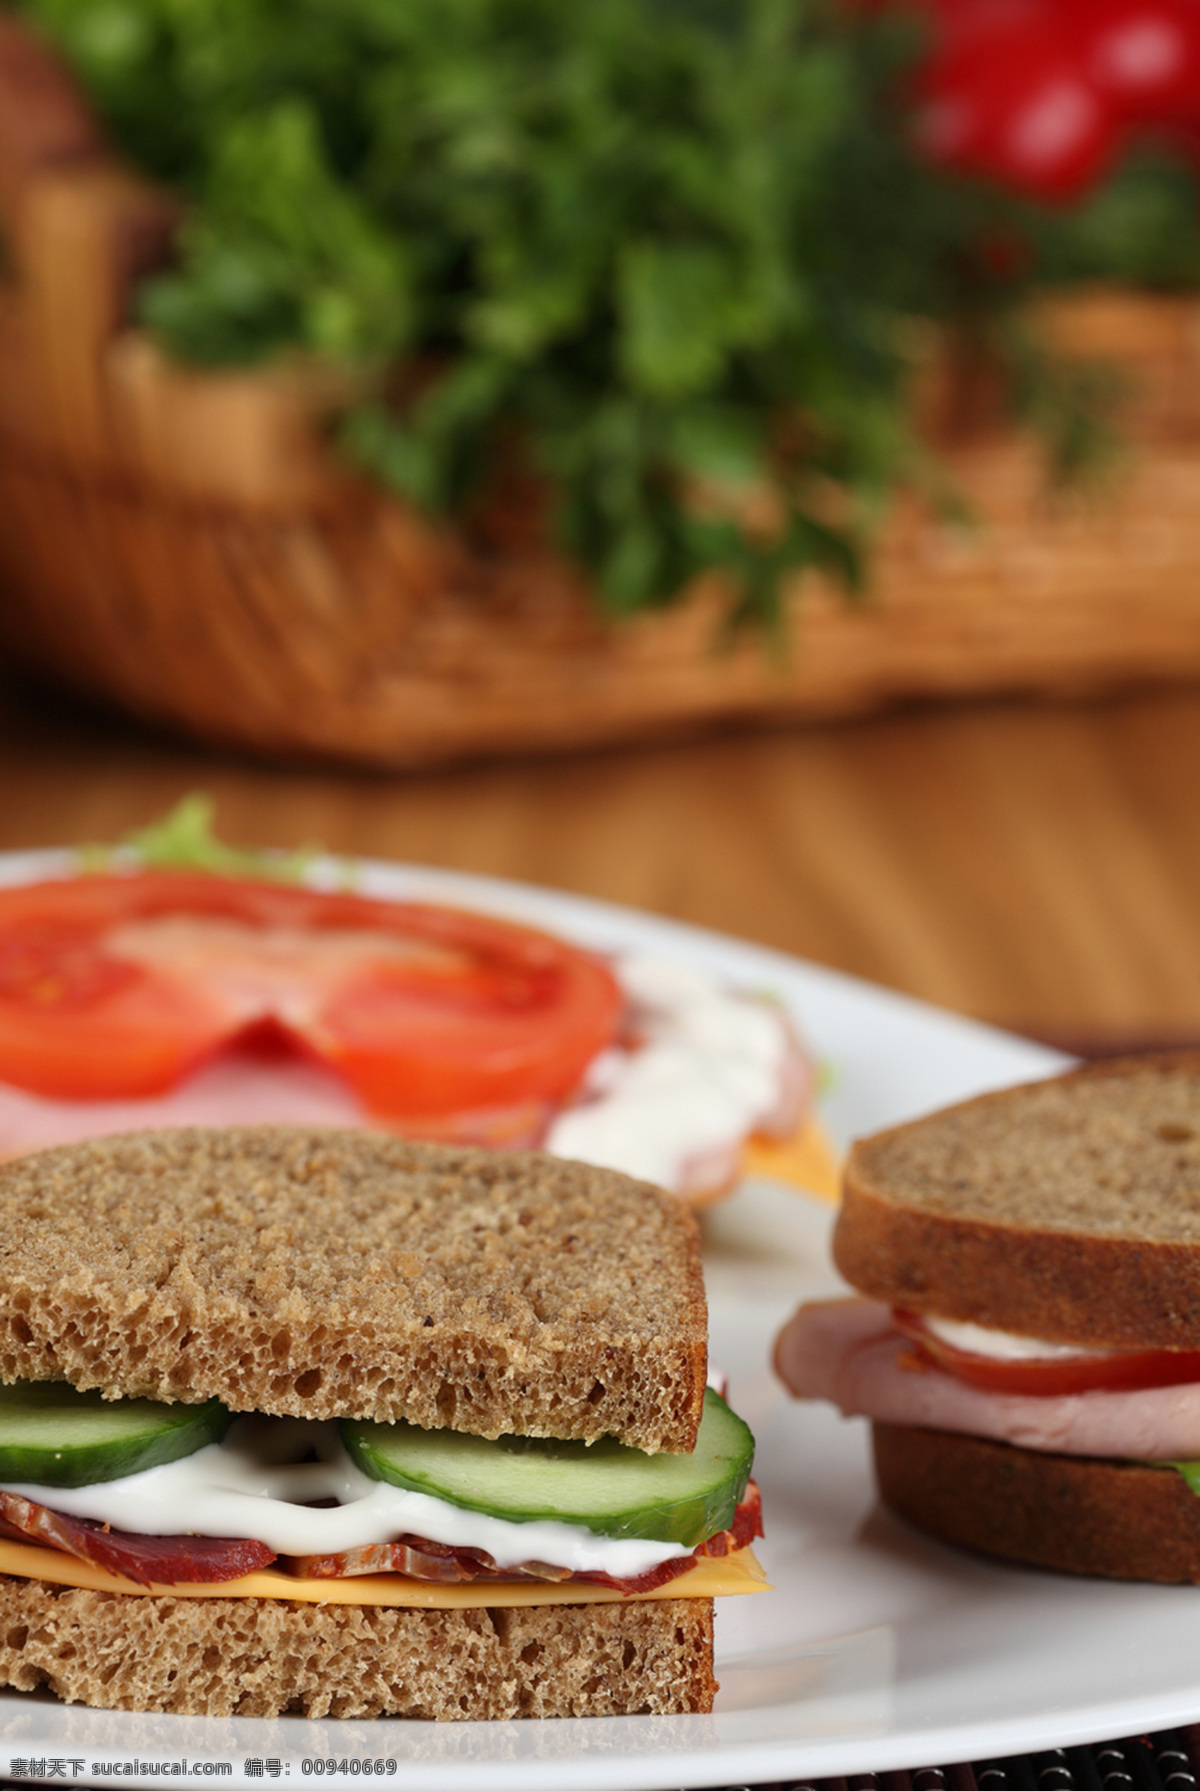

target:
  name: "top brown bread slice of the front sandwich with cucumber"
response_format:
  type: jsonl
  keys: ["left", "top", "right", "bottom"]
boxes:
{"left": 0, "top": 1127, "right": 707, "bottom": 1453}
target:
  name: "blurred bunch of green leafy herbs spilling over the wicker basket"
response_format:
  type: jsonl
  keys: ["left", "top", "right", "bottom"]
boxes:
{"left": 14, "top": 0, "right": 1139, "bottom": 623}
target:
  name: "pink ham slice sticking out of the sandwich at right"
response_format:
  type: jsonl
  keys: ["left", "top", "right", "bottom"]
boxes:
{"left": 776, "top": 1300, "right": 1200, "bottom": 1461}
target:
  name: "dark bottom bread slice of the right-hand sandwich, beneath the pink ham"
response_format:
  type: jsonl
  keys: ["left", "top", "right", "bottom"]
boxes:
{"left": 872, "top": 1424, "right": 1200, "bottom": 1585}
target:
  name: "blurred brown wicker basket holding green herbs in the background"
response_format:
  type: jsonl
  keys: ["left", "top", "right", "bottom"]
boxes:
{"left": 0, "top": 13, "right": 1200, "bottom": 765}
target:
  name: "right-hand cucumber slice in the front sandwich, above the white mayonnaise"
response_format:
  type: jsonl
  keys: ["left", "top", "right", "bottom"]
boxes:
{"left": 342, "top": 1388, "right": 754, "bottom": 1547}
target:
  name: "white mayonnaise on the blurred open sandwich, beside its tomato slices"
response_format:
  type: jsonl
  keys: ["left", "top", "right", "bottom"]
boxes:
{"left": 544, "top": 953, "right": 793, "bottom": 1189}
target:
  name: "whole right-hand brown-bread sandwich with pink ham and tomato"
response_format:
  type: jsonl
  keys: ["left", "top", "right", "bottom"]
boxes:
{"left": 776, "top": 1053, "right": 1200, "bottom": 1581}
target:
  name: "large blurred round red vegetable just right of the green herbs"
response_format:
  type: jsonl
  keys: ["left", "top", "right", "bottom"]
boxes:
{"left": 913, "top": 11, "right": 1118, "bottom": 201}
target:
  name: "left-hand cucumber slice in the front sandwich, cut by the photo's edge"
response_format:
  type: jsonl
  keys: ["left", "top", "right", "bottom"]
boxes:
{"left": 0, "top": 1381, "right": 229, "bottom": 1487}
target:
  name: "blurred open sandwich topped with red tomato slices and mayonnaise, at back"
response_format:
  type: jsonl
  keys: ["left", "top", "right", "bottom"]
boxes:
{"left": 0, "top": 797, "right": 829, "bottom": 1205}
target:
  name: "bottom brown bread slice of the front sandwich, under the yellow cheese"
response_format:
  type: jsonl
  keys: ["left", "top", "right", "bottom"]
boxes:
{"left": 0, "top": 1576, "right": 716, "bottom": 1723}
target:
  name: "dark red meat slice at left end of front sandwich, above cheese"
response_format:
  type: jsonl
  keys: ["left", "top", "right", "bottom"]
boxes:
{"left": 0, "top": 1492, "right": 276, "bottom": 1585}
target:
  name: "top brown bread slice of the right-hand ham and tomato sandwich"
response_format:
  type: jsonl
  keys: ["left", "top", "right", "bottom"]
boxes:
{"left": 833, "top": 1051, "right": 1200, "bottom": 1349}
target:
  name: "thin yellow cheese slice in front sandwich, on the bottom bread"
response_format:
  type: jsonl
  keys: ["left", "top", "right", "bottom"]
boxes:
{"left": 0, "top": 1538, "right": 770, "bottom": 1610}
